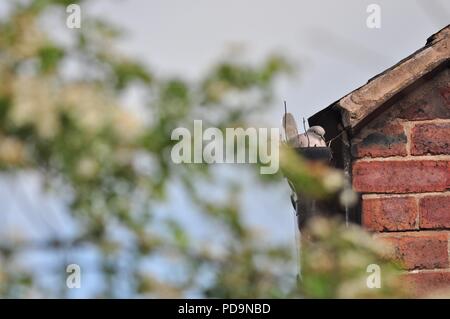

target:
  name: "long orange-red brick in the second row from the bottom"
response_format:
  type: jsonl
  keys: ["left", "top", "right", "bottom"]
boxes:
{"left": 382, "top": 232, "right": 449, "bottom": 270}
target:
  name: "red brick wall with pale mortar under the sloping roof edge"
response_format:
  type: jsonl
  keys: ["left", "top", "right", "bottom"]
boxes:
{"left": 352, "top": 68, "right": 450, "bottom": 294}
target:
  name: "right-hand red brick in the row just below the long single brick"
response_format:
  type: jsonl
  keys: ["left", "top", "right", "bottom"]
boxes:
{"left": 419, "top": 195, "right": 450, "bottom": 229}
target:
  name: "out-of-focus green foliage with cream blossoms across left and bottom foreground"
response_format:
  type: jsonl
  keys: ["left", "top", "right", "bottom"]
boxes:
{"left": 0, "top": 0, "right": 414, "bottom": 298}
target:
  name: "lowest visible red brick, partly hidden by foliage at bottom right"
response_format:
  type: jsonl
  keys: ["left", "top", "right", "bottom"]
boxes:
{"left": 403, "top": 271, "right": 450, "bottom": 297}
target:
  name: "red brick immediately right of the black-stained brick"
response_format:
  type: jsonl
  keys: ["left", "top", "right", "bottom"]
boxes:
{"left": 411, "top": 123, "right": 450, "bottom": 155}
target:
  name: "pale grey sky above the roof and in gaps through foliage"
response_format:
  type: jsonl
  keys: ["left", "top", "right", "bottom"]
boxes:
{"left": 0, "top": 0, "right": 450, "bottom": 296}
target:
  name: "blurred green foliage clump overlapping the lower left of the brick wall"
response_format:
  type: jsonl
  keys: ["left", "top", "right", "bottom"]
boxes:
{"left": 299, "top": 217, "right": 412, "bottom": 298}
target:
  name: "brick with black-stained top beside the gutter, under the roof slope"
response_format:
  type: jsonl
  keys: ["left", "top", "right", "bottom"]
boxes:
{"left": 352, "top": 122, "right": 407, "bottom": 158}
